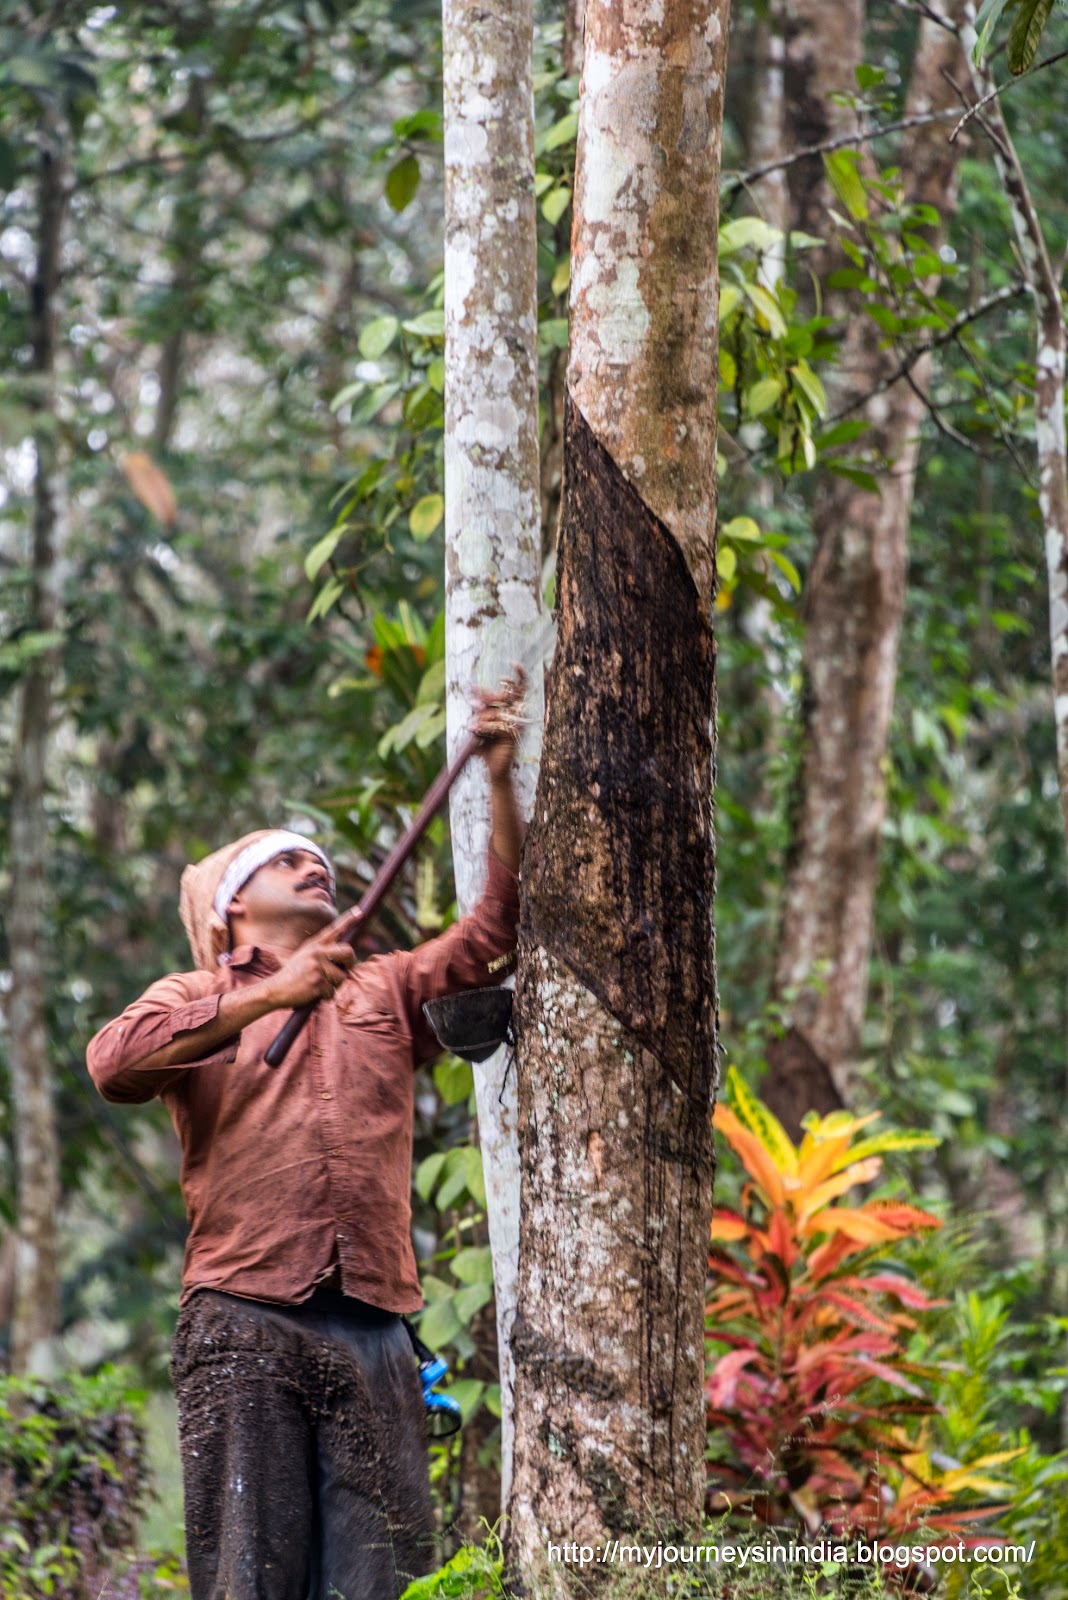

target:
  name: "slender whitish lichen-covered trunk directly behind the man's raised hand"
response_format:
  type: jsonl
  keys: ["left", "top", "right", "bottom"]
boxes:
{"left": 443, "top": 0, "right": 542, "bottom": 1520}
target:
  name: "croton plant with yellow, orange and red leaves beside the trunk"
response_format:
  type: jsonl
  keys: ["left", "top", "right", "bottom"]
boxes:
{"left": 707, "top": 1069, "right": 1014, "bottom": 1568}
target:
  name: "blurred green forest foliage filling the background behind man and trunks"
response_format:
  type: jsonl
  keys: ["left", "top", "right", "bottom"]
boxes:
{"left": 0, "top": 0, "right": 1068, "bottom": 1597}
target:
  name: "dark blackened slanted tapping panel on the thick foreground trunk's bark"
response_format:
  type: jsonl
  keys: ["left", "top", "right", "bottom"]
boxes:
{"left": 523, "top": 400, "right": 716, "bottom": 1104}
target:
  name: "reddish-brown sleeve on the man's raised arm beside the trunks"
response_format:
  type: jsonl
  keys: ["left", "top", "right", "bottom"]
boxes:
{"left": 398, "top": 850, "right": 520, "bottom": 1062}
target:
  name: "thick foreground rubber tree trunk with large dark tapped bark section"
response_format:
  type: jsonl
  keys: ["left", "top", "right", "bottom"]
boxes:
{"left": 507, "top": 0, "right": 729, "bottom": 1594}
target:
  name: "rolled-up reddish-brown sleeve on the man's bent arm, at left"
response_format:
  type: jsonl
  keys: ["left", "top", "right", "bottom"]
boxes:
{"left": 86, "top": 973, "right": 240, "bottom": 1106}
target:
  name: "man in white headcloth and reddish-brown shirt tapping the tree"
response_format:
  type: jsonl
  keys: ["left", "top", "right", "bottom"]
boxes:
{"left": 88, "top": 696, "right": 521, "bottom": 1600}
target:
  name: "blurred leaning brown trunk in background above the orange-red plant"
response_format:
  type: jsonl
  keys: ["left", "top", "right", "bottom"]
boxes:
{"left": 764, "top": 19, "right": 964, "bottom": 1138}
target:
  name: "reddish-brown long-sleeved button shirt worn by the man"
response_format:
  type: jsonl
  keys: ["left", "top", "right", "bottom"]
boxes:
{"left": 88, "top": 851, "right": 518, "bottom": 1312}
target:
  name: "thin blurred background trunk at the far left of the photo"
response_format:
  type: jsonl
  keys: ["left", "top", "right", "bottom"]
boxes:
{"left": 8, "top": 125, "right": 69, "bottom": 1376}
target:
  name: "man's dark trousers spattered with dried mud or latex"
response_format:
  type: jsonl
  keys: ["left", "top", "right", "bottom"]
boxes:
{"left": 171, "top": 1290, "right": 433, "bottom": 1600}
